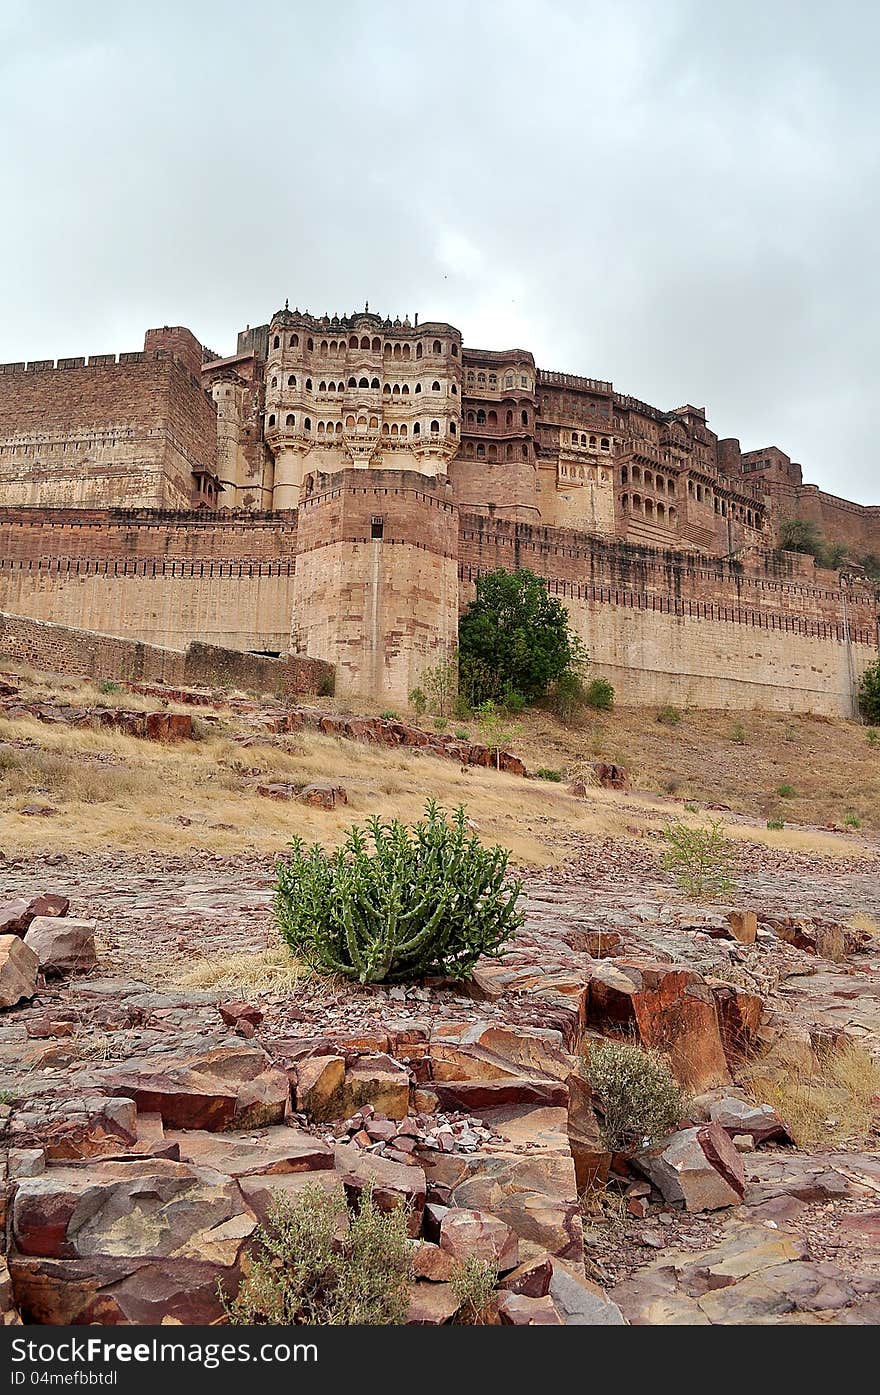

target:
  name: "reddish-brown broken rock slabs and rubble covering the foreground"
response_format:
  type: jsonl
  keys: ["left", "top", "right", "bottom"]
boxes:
{"left": 0, "top": 820, "right": 880, "bottom": 1325}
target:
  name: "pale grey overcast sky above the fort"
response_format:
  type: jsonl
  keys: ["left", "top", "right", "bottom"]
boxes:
{"left": 0, "top": 0, "right": 880, "bottom": 502}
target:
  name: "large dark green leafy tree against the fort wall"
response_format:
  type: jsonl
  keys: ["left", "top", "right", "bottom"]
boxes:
{"left": 459, "top": 568, "right": 587, "bottom": 706}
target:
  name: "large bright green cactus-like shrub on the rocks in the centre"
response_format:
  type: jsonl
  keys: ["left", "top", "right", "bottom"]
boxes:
{"left": 275, "top": 799, "right": 523, "bottom": 983}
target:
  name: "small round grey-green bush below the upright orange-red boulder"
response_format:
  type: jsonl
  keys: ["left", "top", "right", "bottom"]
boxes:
{"left": 586, "top": 1041, "right": 685, "bottom": 1152}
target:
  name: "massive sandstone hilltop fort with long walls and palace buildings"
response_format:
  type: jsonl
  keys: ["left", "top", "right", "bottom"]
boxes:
{"left": 0, "top": 306, "right": 880, "bottom": 716}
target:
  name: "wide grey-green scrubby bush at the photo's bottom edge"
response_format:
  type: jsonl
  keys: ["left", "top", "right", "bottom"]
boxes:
{"left": 225, "top": 1183, "right": 411, "bottom": 1327}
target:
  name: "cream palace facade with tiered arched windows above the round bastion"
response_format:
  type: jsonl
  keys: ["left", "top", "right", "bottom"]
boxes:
{"left": 265, "top": 308, "right": 462, "bottom": 509}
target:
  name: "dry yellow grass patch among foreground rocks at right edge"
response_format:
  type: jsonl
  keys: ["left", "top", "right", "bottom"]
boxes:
{"left": 743, "top": 1041, "right": 880, "bottom": 1148}
